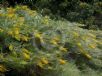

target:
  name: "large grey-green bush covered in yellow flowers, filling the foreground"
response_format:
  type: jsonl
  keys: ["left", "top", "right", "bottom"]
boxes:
{"left": 0, "top": 6, "right": 102, "bottom": 76}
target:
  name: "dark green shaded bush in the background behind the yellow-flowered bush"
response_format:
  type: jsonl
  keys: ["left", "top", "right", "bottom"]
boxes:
{"left": 1, "top": 0, "right": 102, "bottom": 29}
